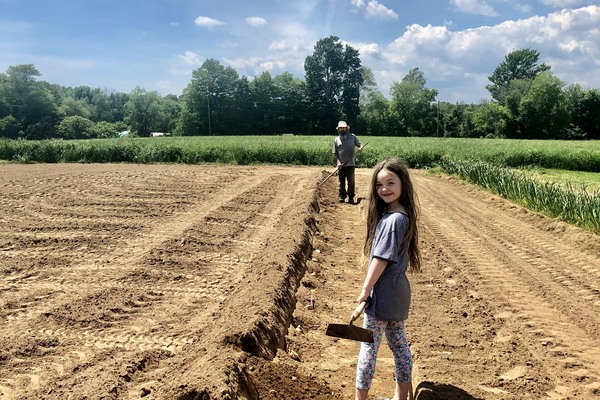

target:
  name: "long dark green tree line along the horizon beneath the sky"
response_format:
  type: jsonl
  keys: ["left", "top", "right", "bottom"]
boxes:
{"left": 0, "top": 36, "right": 600, "bottom": 139}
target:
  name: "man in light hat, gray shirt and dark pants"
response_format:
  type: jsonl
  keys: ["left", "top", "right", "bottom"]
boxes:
{"left": 333, "top": 121, "right": 363, "bottom": 204}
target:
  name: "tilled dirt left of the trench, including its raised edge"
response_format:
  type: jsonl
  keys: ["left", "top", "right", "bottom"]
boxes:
{"left": 0, "top": 165, "right": 322, "bottom": 400}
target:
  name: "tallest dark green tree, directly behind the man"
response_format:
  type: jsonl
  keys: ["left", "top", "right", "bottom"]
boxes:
{"left": 304, "top": 36, "right": 363, "bottom": 132}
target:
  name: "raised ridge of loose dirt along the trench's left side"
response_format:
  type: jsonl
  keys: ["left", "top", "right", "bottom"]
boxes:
{"left": 156, "top": 190, "right": 317, "bottom": 399}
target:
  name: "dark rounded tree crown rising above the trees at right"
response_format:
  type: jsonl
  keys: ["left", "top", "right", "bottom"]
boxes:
{"left": 485, "top": 48, "right": 550, "bottom": 105}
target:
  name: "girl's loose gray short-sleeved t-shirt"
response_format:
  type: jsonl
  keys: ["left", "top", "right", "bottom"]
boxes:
{"left": 365, "top": 212, "right": 410, "bottom": 321}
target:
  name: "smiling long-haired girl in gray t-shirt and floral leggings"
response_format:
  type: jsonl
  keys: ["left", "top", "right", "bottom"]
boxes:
{"left": 356, "top": 157, "right": 421, "bottom": 400}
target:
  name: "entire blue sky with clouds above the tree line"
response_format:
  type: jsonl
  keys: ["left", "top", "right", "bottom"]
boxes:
{"left": 0, "top": 0, "right": 600, "bottom": 103}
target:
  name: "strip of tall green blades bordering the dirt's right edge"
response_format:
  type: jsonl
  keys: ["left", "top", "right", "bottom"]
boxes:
{"left": 440, "top": 158, "right": 600, "bottom": 234}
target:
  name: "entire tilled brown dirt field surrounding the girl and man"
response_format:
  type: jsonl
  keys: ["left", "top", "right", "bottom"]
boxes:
{"left": 0, "top": 165, "right": 600, "bottom": 400}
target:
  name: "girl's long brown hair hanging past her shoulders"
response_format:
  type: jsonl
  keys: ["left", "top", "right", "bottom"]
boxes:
{"left": 363, "top": 157, "right": 421, "bottom": 272}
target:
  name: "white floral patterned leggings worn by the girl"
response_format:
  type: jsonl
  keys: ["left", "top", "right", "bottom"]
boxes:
{"left": 356, "top": 314, "right": 412, "bottom": 390}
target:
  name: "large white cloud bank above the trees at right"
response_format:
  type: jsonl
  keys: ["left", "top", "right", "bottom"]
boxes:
{"left": 361, "top": 6, "right": 600, "bottom": 101}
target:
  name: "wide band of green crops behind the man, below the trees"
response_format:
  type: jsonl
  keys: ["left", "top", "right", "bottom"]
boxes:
{"left": 0, "top": 135, "right": 600, "bottom": 172}
